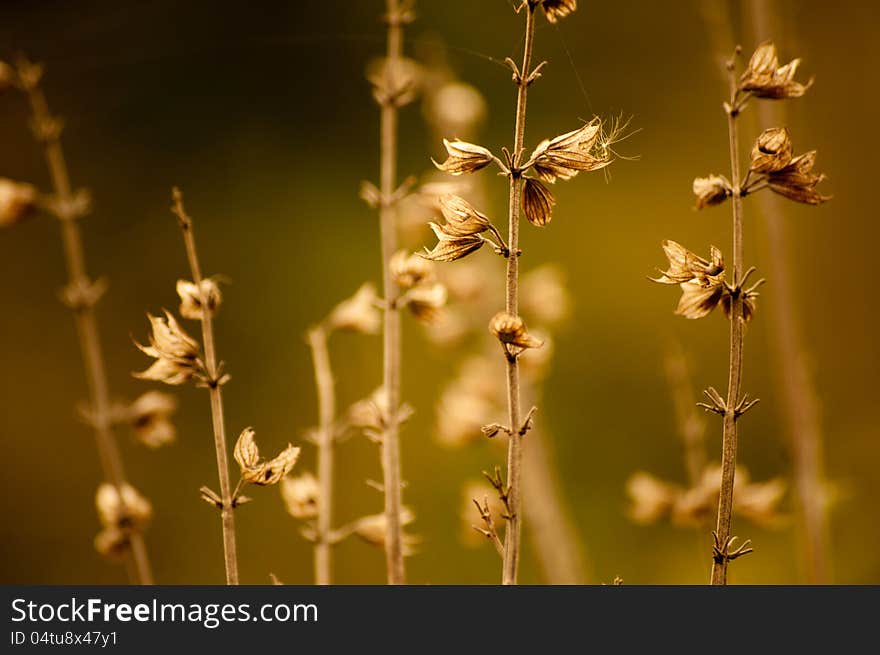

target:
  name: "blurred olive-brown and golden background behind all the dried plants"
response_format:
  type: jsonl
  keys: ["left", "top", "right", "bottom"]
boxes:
{"left": 0, "top": 0, "right": 880, "bottom": 584}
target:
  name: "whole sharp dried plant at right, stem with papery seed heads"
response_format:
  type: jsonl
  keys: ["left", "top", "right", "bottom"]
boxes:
{"left": 655, "top": 41, "right": 828, "bottom": 585}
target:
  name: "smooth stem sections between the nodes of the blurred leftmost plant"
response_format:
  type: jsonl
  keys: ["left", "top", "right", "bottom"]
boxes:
{"left": 20, "top": 66, "right": 153, "bottom": 585}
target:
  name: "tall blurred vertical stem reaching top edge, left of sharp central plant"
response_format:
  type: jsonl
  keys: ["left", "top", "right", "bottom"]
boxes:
{"left": 379, "top": 0, "right": 405, "bottom": 584}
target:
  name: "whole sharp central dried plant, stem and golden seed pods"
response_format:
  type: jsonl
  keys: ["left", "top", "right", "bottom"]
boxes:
{"left": 423, "top": 0, "right": 610, "bottom": 584}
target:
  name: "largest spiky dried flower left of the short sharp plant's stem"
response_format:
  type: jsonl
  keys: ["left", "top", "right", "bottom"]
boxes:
{"left": 134, "top": 311, "right": 202, "bottom": 385}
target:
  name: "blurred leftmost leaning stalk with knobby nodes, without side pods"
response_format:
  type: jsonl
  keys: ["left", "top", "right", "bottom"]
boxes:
{"left": 15, "top": 58, "right": 153, "bottom": 585}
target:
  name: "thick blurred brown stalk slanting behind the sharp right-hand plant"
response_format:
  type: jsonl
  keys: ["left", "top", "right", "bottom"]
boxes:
{"left": 749, "top": 0, "right": 831, "bottom": 584}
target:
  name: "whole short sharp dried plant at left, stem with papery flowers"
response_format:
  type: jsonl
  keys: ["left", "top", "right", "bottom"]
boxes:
{"left": 134, "top": 188, "right": 300, "bottom": 585}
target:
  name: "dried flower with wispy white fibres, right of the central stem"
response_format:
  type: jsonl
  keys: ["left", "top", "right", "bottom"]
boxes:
{"left": 529, "top": 118, "right": 611, "bottom": 183}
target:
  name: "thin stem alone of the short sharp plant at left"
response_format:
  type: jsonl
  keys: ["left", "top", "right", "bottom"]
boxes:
{"left": 172, "top": 188, "right": 238, "bottom": 585}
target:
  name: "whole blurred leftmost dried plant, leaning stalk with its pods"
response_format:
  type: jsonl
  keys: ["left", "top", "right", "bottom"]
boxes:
{"left": 0, "top": 57, "right": 160, "bottom": 584}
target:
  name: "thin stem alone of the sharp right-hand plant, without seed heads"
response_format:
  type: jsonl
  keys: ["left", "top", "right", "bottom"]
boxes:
{"left": 712, "top": 64, "right": 744, "bottom": 585}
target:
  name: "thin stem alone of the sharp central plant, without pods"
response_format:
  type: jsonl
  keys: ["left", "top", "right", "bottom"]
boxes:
{"left": 501, "top": 2, "right": 537, "bottom": 585}
